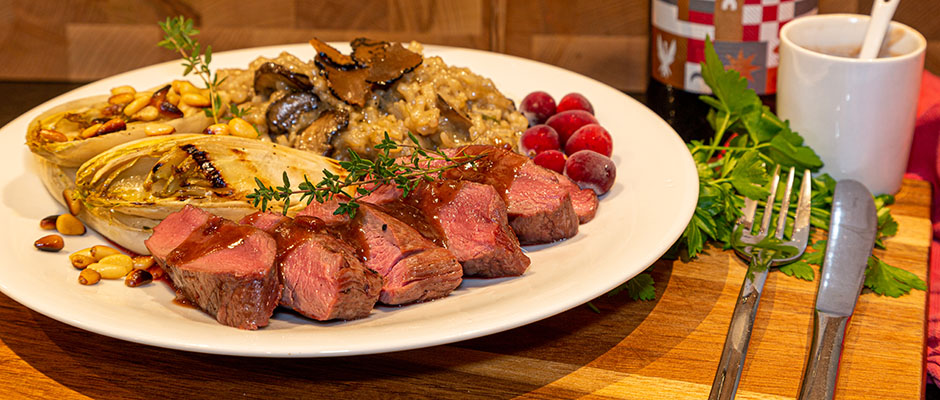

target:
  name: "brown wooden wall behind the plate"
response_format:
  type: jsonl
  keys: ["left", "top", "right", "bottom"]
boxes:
{"left": 0, "top": 0, "right": 940, "bottom": 92}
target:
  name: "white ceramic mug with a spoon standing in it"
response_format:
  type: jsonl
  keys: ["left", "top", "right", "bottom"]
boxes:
{"left": 777, "top": 14, "right": 927, "bottom": 194}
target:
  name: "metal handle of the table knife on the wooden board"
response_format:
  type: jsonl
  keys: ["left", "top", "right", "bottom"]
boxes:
{"left": 798, "top": 310, "right": 849, "bottom": 400}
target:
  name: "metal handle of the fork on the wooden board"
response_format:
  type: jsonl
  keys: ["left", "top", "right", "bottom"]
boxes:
{"left": 708, "top": 268, "right": 769, "bottom": 400}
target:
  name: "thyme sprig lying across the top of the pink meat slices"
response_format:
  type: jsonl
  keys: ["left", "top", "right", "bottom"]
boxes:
{"left": 246, "top": 133, "right": 483, "bottom": 217}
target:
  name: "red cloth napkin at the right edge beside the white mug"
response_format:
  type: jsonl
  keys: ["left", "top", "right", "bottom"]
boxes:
{"left": 907, "top": 71, "right": 940, "bottom": 382}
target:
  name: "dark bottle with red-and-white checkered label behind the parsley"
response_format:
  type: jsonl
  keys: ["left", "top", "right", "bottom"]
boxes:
{"left": 646, "top": 0, "right": 818, "bottom": 141}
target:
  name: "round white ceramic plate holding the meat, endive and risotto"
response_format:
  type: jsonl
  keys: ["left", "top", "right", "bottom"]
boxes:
{"left": 0, "top": 44, "right": 698, "bottom": 357}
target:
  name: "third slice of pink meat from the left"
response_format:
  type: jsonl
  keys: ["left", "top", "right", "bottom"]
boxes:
{"left": 298, "top": 199, "right": 463, "bottom": 305}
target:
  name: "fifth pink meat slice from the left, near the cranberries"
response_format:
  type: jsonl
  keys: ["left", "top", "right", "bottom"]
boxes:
{"left": 443, "top": 145, "right": 578, "bottom": 244}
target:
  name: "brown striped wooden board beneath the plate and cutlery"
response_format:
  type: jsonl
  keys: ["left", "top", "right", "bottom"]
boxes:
{"left": 0, "top": 180, "right": 931, "bottom": 399}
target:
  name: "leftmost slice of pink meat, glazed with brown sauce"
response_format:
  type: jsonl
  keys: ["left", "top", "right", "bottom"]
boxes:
{"left": 144, "top": 206, "right": 280, "bottom": 330}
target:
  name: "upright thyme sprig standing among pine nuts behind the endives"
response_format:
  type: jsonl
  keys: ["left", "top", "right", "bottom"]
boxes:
{"left": 157, "top": 15, "right": 227, "bottom": 124}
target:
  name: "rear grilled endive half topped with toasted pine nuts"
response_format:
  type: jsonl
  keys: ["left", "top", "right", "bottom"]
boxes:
{"left": 26, "top": 93, "right": 212, "bottom": 167}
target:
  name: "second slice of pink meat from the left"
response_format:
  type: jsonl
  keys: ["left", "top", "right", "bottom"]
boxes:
{"left": 243, "top": 213, "right": 382, "bottom": 321}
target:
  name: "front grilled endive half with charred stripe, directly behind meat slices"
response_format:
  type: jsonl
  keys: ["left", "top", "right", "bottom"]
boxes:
{"left": 75, "top": 134, "right": 345, "bottom": 254}
